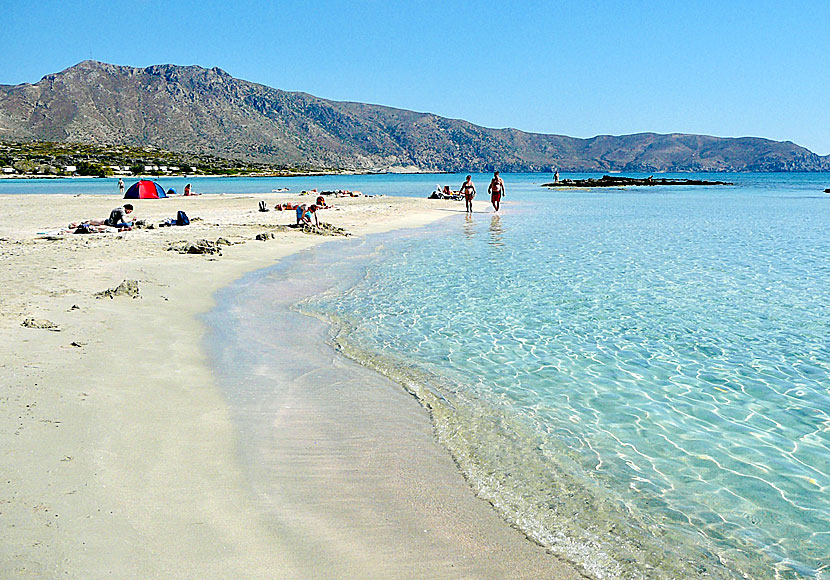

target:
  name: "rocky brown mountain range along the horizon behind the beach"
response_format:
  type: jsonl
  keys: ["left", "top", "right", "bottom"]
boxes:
{"left": 0, "top": 61, "right": 830, "bottom": 173}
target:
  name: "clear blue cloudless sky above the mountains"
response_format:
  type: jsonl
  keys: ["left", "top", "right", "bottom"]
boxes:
{"left": 6, "top": 0, "right": 830, "bottom": 154}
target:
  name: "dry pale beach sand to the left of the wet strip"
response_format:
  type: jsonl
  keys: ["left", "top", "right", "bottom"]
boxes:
{"left": 0, "top": 194, "right": 577, "bottom": 578}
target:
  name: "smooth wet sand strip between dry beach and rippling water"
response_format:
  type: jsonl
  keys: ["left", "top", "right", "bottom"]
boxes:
{"left": 207, "top": 232, "right": 585, "bottom": 579}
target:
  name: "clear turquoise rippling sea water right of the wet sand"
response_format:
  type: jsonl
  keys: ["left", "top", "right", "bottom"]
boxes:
{"left": 301, "top": 174, "right": 830, "bottom": 578}
